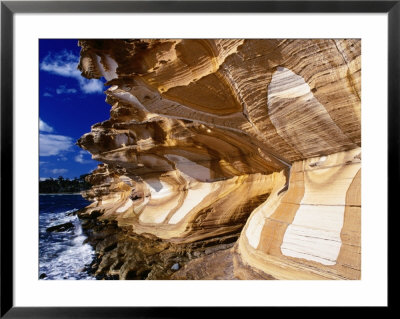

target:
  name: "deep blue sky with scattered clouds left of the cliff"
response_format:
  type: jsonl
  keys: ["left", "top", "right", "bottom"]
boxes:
{"left": 39, "top": 39, "right": 110, "bottom": 179}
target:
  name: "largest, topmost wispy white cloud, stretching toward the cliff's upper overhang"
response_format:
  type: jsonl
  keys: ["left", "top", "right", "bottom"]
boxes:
{"left": 40, "top": 50, "right": 103, "bottom": 94}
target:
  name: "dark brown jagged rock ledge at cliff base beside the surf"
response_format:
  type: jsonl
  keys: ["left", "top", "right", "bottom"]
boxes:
{"left": 82, "top": 211, "right": 239, "bottom": 280}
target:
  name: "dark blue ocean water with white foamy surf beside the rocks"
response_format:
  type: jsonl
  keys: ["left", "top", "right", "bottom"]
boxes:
{"left": 38, "top": 194, "right": 95, "bottom": 280}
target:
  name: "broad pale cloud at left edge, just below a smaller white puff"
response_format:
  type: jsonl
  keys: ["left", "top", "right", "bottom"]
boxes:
{"left": 39, "top": 133, "right": 74, "bottom": 156}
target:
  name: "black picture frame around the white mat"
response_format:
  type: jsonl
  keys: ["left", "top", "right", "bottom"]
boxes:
{"left": 0, "top": 0, "right": 394, "bottom": 318}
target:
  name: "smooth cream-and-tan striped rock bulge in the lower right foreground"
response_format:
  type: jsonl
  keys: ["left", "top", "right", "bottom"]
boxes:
{"left": 235, "top": 148, "right": 361, "bottom": 279}
